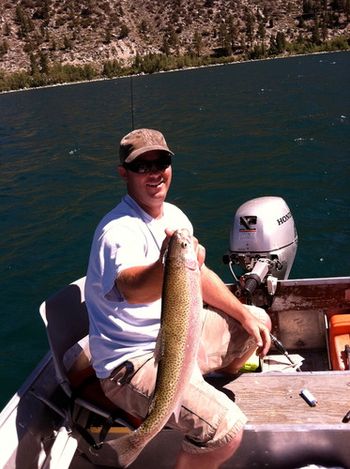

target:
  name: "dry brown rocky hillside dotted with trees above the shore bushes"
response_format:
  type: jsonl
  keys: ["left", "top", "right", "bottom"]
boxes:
{"left": 0, "top": 0, "right": 350, "bottom": 72}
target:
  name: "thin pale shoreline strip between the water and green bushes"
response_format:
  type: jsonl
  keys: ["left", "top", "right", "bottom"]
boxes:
{"left": 0, "top": 49, "right": 350, "bottom": 96}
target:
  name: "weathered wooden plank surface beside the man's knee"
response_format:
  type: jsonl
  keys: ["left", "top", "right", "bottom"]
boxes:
{"left": 217, "top": 371, "right": 350, "bottom": 425}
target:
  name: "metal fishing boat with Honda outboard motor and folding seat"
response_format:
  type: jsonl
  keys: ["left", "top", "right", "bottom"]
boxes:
{"left": 0, "top": 198, "right": 350, "bottom": 469}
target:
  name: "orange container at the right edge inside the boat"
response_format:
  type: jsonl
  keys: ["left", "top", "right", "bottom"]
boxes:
{"left": 329, "top": 314, "right": 350, "bottom": 370}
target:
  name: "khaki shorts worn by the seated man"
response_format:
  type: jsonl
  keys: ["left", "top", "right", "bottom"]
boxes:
{"left": 101, "top": 307, "right": 266, "bottom": 453}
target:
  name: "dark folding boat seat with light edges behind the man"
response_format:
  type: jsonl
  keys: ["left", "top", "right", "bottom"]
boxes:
{"left": 39, "top": 277, "right": 139, "bottom": 436}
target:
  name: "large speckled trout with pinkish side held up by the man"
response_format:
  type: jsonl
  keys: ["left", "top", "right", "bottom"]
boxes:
{"left": 116, "top": 229, "right": 202, "bottom": 467}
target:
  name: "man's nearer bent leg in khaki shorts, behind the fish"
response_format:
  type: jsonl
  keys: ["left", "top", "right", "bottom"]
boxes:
{"left": 101, "top": 354, "right": 247, "bottom": 469}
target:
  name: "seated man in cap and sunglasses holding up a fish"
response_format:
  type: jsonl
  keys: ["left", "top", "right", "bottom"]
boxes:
{"left": 85, "top": 129, "right": 271, "bottom": 469}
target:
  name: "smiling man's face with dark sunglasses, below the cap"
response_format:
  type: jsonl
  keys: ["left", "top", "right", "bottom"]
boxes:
{"left": 119, "top": 151, "right": 172, "bottom": 217}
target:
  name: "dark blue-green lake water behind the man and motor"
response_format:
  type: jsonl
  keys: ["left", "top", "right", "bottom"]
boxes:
{"left": 0, "top": 52, "right": 350, "bottom": 406}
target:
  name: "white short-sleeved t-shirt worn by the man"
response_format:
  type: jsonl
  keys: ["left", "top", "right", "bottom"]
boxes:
{"left": 85, "top": 195, "right": 193, "bottom": 378}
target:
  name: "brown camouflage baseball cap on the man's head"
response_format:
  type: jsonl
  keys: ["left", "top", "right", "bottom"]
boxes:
{"left": 119, "top": 129, "right": 174, "bottom": 164}
